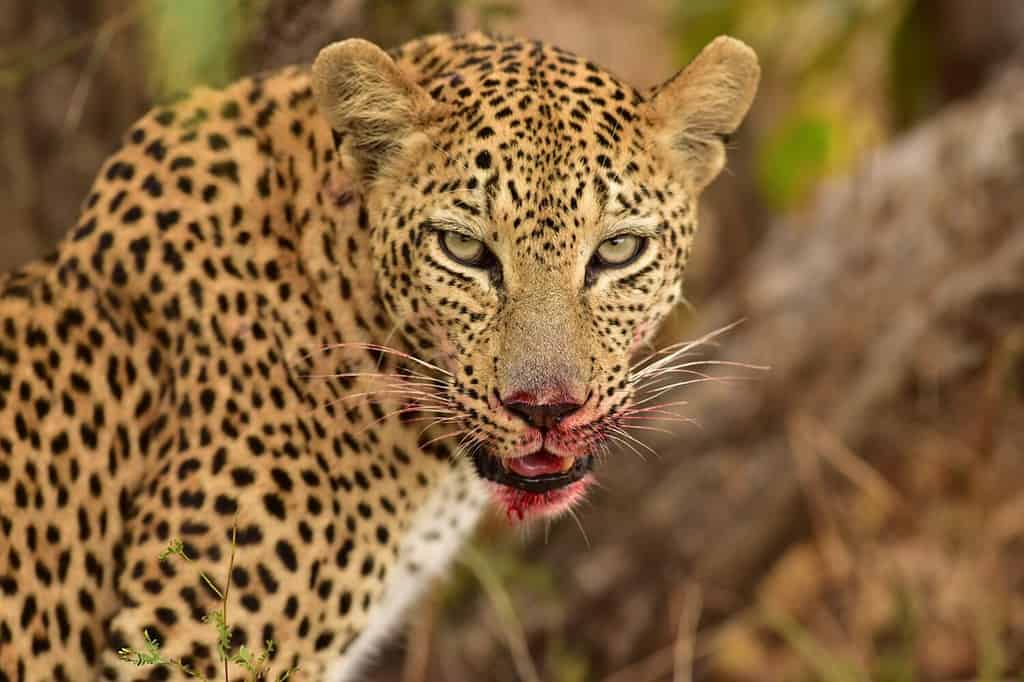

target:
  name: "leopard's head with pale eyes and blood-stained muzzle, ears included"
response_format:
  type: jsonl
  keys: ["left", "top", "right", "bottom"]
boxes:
{"left": 313, "top": 36, "right": 759, "bottom": 517}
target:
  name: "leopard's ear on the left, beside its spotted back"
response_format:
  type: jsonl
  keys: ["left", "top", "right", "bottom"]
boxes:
{"left": 312, "top": 38, "right": 434, "bottom": 181}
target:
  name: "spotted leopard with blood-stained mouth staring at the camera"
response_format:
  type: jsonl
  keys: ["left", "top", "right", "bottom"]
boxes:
{"left": 0, "top": 33, "right": 760, "bottom": 682}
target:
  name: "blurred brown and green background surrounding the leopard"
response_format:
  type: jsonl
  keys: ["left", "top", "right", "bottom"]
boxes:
{"left": 0, "top": 0, "right": 1024, "bottom": 682}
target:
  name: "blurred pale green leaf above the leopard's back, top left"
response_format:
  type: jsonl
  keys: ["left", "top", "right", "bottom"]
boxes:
{"left": 140, "top": 0, "right": 267, "bottom": 100}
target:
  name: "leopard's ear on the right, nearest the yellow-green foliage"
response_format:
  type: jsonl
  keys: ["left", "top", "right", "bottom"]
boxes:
{"left": 647, "top": 36, "right": 761, "bottom": 191}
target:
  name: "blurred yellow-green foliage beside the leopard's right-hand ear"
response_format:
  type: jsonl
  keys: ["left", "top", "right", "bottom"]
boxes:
{"left": 675, "top": 0, "right": 936, "bottom": 210}
